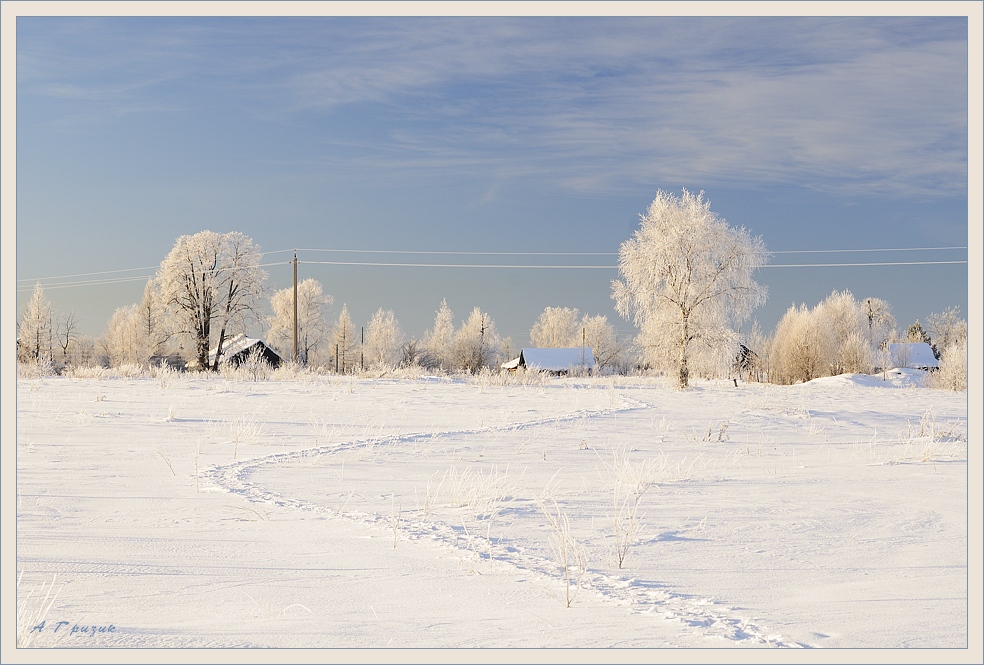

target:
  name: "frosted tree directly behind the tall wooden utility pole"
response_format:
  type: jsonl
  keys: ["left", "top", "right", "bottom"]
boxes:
{"left": 267, "top": 278, "right": 335, "bottom": 365}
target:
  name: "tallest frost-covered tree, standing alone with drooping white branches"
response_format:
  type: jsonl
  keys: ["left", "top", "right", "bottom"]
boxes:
{"left": 612, "top": 190, "right": 768, "bottom": 388}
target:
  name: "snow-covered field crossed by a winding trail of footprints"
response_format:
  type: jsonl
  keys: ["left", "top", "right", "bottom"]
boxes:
{"left": 16, "top": 373, "right": 968, "bottom": 649}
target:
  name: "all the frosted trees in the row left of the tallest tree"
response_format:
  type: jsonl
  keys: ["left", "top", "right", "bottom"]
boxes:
{"left": 18, "top": 231, "right": 632, "bottom": 373}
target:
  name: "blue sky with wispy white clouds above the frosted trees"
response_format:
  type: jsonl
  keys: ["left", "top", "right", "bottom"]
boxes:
{"left": 11, "top": 10, "right": 968, "bottom": 345}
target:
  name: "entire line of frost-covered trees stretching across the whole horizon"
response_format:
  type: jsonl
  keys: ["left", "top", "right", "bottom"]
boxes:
{"left": 17, "top": 190, "right": 967, "bottom": 389}
